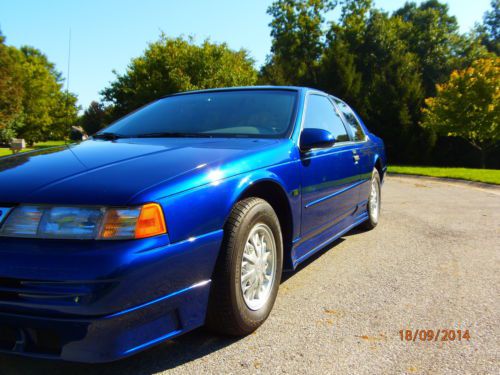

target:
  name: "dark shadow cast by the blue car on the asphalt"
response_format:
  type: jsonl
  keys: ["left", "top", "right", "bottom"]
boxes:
{"left": 0, "top": 236, "right": 354, "bottom": 375}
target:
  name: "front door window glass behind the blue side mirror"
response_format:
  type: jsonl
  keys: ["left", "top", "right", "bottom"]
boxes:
{"left": 304, "top": 94, "right": 349, "bottom": 142}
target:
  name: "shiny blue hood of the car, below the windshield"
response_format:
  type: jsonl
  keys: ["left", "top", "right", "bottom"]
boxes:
{"left": 0, "top": 138, "right": 291, "bottom": 205}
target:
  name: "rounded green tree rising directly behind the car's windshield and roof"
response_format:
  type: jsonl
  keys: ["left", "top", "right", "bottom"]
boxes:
{"left": 101, "top": 34, "right": 257, "bottom": 118}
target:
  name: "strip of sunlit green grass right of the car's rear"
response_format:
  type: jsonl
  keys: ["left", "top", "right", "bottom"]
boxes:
{"left": 388, "top": 165, "right": 500, "bottom": 185}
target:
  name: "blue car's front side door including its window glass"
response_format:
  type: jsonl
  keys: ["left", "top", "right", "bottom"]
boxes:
{"left": 297, "top": 94, "right": 359, "bottom": 244}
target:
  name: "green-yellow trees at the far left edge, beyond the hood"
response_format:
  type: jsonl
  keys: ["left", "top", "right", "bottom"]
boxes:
{"left": 0, "top": 33, "right": 78, "bottom": 144}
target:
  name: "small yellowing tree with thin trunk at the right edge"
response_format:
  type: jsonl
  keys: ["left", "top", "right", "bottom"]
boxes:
{"left": 421, "top": 57, "right": 500, "bottom": 168}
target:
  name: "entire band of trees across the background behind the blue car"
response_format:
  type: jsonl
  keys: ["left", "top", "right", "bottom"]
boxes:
{"left": 0, "top": 0, "right": 500, "bottom": 168}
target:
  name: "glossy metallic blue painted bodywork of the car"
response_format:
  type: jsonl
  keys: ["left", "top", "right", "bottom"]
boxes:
{"left": 0, "top": 87, "right": 386, "bottom": 362}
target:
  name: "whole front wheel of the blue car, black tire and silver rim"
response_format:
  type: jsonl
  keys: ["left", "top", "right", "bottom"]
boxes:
{"left": 206, "top": 198, "right": 283, "bottom": 336}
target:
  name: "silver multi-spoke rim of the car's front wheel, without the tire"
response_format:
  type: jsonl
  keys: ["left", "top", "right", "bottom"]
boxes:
{"left": 241, "top": 223, "right": 276, "bottom": 311}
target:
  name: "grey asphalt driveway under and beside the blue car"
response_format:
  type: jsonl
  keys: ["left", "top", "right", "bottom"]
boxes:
{"left": 0, "top": 177, "right": 500, "bottom": 375}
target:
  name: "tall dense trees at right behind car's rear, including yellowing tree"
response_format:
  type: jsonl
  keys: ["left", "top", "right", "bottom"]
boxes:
{"left": 261, "top": 0, "right": 500, "bottom": 167}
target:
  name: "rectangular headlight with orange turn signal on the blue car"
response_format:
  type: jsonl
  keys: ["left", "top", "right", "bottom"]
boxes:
{"left": 0, "top": 203, "right": 167, "bottom": 240}
